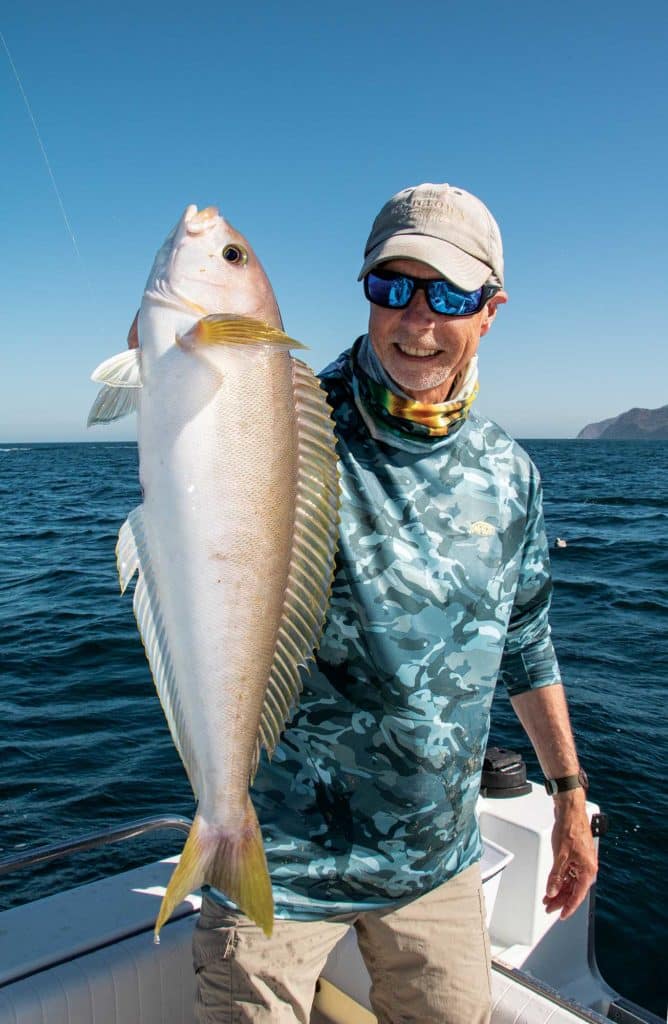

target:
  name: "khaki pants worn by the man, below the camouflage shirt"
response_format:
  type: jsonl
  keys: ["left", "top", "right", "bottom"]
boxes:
{"left": 193, "top": 864, "right": 490, "bottom": 1024}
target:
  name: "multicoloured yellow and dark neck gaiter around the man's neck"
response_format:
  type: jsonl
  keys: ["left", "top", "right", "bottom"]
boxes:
{"left": 351, "top": 335, "right": 479, "bottom": 437}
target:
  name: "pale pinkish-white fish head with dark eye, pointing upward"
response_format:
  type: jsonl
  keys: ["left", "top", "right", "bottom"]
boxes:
{"left": 144, "top": 205, "right": 283, "bottom": 329}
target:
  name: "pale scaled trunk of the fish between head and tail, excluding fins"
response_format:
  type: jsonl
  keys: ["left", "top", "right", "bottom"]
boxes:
{"left": 139, "top": 346, "right": 297, "bottom": 828}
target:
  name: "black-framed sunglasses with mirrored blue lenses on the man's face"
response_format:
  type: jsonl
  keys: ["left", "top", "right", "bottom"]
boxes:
{"left": 364, "top": 270, "right": 499, "bottom": 316}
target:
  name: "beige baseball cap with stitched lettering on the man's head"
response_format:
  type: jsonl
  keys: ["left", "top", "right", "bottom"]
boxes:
{"left": 358, "top": 182, "right": 503, "bottom": 292}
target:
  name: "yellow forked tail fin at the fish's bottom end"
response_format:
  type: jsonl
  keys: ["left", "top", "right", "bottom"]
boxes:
{"left": 154, "top": 797, "right": 274, "bottom": 942}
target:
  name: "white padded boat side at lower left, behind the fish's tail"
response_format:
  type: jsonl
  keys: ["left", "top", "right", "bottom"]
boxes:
{"left": 0, "top": 857, "right": 200, "bottom": 1024}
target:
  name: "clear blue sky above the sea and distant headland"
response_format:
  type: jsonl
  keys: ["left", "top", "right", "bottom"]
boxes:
{"left": 0, "top": 0, "right": 668, "bottom": 442}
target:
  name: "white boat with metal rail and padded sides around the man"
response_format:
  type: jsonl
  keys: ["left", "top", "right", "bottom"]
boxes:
{"left": 0, "top": 751, "right": 660, "bottom": 1024}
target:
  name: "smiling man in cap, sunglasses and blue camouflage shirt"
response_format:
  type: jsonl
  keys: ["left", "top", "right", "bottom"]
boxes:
{"left": 194, "top": 184, "right": 596, "bottom": 1024}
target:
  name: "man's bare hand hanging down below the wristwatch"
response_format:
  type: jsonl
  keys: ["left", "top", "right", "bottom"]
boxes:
{"left": 543, "top": 790, "right": 598, "bottom": 921}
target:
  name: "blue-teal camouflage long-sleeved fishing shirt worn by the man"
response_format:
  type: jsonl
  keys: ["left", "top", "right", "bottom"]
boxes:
{"left": 206, "top": 342, "right": 559, "bottom": 920}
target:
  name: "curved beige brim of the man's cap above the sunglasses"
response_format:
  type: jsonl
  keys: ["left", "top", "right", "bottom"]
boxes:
{"left": 358, "top": 234, "right": 494, "bottom": 292}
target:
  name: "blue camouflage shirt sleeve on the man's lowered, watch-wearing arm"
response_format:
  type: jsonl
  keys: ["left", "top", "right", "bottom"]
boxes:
{"left": 499, "top": 465, "right": 560, "bottom": 697}
